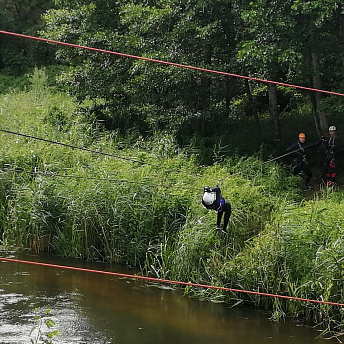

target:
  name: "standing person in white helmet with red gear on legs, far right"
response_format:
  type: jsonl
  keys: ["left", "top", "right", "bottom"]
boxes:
{"left": 324, "top": 125, "right": 339, "bottom": 187}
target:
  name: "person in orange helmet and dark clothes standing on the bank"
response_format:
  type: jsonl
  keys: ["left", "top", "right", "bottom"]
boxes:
{"left": 287, "top": 133, "right": 321, "bottom": 190}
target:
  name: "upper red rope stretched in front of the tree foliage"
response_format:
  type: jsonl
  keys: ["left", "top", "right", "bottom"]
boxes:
{"left": 0, "top": 30, "right": 344, "bottom": 97}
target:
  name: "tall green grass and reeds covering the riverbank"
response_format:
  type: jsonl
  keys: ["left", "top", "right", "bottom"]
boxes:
{"left": 0, "top": 74, "right": 344, "bottom": 330}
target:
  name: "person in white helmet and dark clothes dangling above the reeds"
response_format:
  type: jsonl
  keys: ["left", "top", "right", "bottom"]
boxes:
{"left": 202, "top": 186, "right": 232, "bottom": 234}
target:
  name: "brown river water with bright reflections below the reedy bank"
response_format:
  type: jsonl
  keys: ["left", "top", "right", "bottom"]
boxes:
{"left": 0, "top": 251, "right": 334, "bottom": 344}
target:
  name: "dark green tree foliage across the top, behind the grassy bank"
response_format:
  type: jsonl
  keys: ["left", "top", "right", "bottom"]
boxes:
{"left": 0, "top": 0, "right": 344, "bottom": 147}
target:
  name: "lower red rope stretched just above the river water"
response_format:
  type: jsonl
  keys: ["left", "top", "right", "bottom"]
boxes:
{"left": 0, "top": 258, "right": 344, "bottom": 307}
